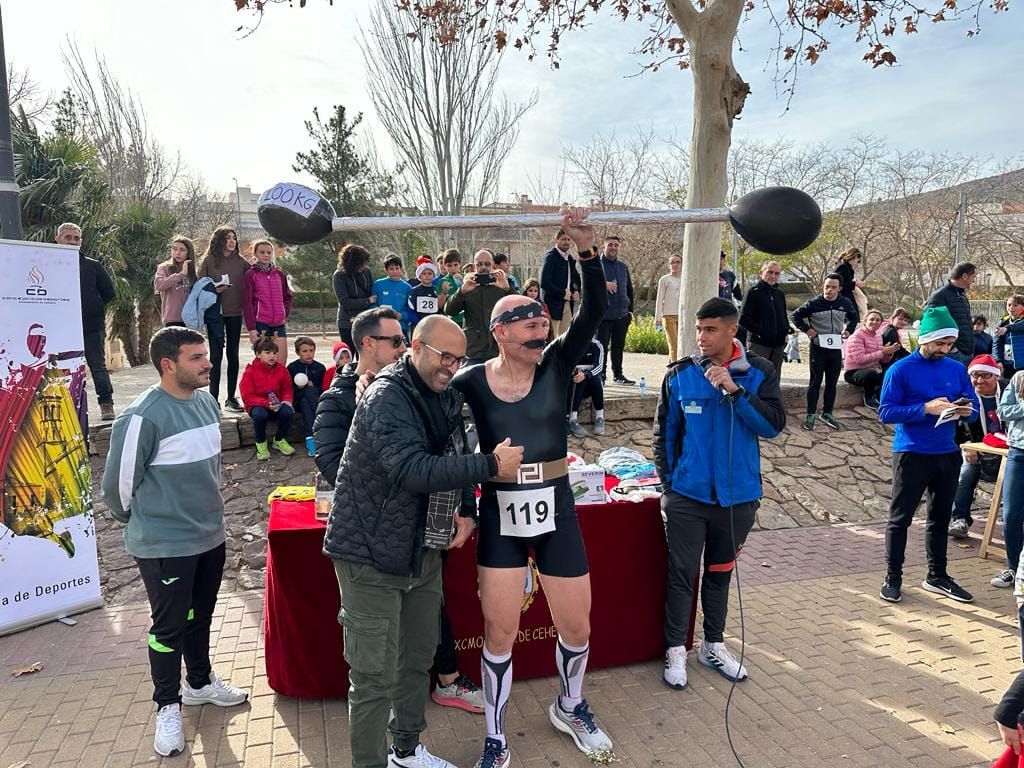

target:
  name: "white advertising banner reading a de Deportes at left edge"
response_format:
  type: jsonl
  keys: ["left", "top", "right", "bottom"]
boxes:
{"left": 0, "top": 240, "right": 102, "bottom": 635}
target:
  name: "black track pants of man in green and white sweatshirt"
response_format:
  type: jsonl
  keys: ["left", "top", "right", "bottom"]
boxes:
{"left": 135, "top": 544, "right": 224, "bottom": 709}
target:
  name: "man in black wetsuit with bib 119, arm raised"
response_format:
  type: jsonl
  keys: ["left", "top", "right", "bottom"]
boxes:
{"left": 452, "top": 209, "right": 611, "bottom": 768}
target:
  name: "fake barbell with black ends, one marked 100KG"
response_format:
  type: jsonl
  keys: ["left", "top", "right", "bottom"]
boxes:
{"left": 257, "top": 182, "right": 821, "bottom": 255}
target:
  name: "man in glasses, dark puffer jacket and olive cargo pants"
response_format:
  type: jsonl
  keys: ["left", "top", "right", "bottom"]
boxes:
{"left": 324, "top": 315, "right": 524, "bottom": 768}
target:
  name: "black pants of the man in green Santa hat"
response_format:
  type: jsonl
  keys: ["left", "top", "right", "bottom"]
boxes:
{"left": 886, "top": 451, "right": 962, "bottom": 577}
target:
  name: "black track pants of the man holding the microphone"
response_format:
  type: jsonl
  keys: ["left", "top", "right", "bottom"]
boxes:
{"left": 662, "top": 490, "right": 759, "bottom": 647}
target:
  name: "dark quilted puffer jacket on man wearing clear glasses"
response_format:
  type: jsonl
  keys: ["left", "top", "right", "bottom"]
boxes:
{"left": 324, "top": 355, "right": 498, "bottom": 577}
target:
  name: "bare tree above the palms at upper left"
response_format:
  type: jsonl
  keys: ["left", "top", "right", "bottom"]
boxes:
{"left": 60, "top": 39, "right": 184, "bottom": 206}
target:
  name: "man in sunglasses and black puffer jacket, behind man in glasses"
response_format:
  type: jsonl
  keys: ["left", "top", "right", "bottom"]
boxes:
{"left": 313, "top": 306, "right": 406, "bottom": 485}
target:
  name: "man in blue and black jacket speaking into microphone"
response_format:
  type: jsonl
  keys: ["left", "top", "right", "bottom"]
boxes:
{"left": 653, "top": 298, "right": 785, "bottom": 688}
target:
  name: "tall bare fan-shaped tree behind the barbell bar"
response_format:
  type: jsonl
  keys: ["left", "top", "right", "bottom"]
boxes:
{"left": 360, "top": 0, "right": 537, "bottom": 222}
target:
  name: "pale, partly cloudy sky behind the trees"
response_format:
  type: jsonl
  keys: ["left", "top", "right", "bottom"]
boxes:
{"left": 3, "top": 0, "right": 1024, "bottom": 202}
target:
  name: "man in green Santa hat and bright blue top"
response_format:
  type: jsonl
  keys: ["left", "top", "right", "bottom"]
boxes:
{"left": 879, "top": 306, "right": 978, "bottom": 603}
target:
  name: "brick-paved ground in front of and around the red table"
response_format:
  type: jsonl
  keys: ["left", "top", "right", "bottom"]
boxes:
{"left": 0, "top": 523, "right": 1021, "bottom": 768}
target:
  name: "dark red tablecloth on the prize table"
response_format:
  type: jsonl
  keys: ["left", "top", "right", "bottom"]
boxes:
{"left": 264, "top": 489, "right": 696, "bottom": 698}
